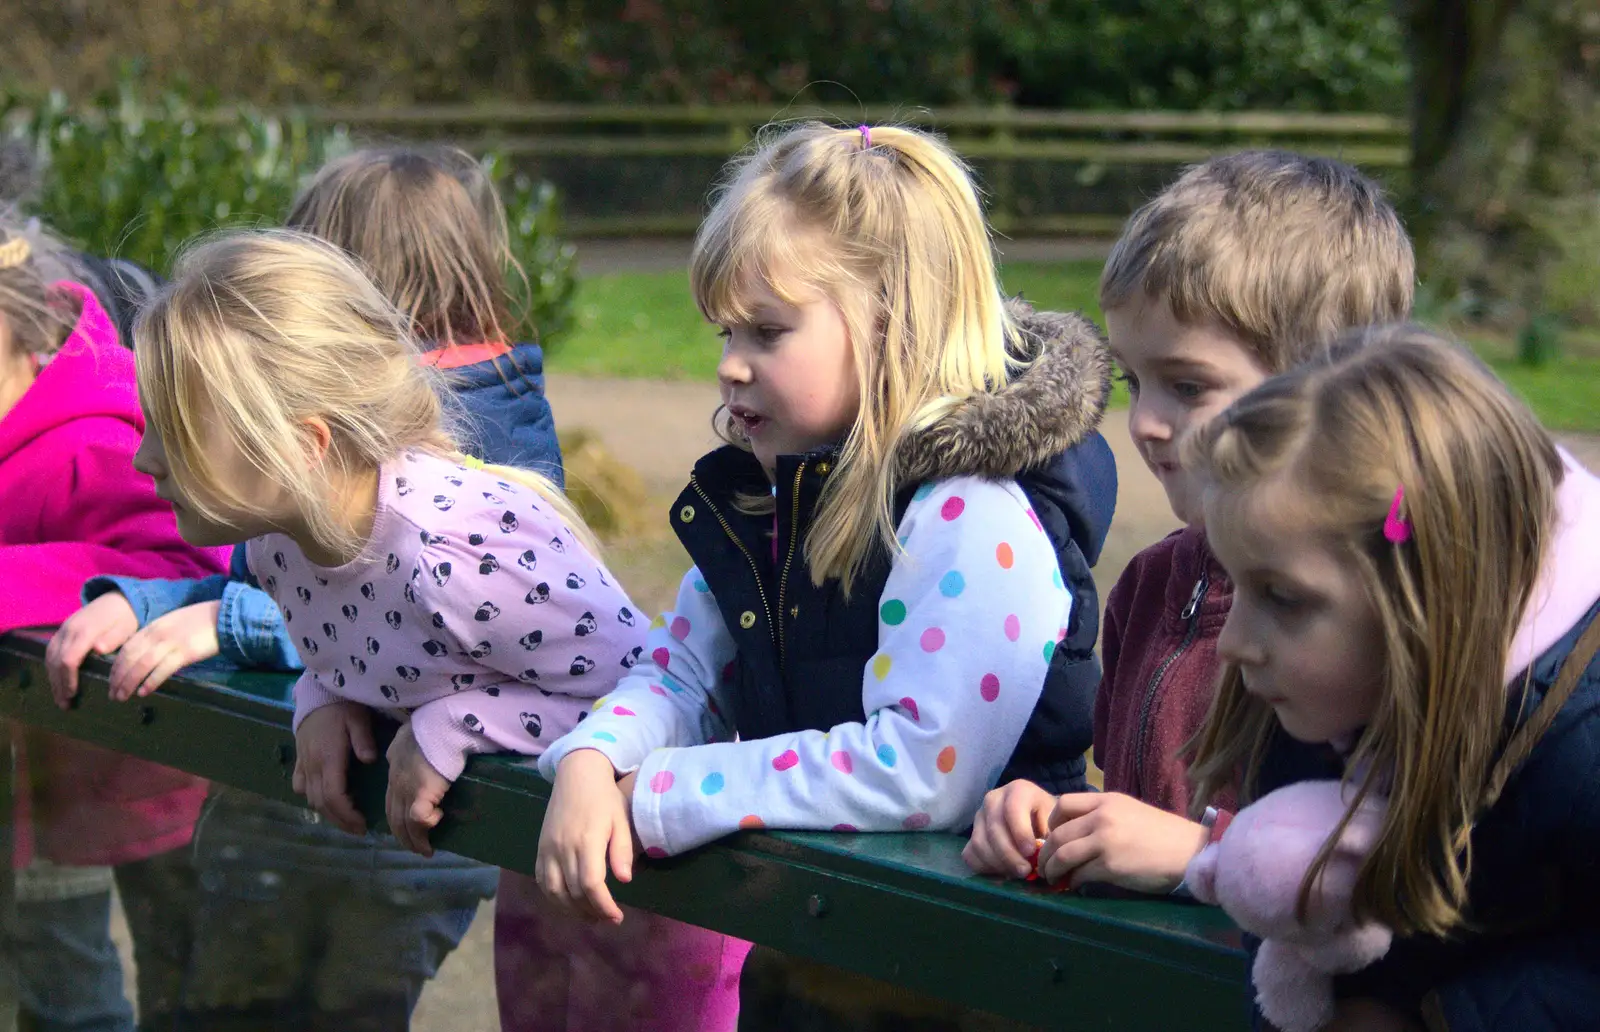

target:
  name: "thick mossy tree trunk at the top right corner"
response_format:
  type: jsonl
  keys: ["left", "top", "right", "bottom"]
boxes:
{"left": 1402, "top": 0, "right": 1600, "bottom": 326}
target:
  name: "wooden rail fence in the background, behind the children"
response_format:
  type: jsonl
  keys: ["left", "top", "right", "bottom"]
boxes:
{"left": 291, "top": 102, "right": 1410, "bottom": 235}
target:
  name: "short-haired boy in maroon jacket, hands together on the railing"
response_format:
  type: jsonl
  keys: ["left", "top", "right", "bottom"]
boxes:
{"left": 966, "top": 150, "right": 1416, "bottom": 893}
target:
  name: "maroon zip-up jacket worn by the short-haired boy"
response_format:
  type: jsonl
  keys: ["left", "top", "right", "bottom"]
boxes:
{"left": 1094, "top": 526, "right": 1234, "bottom": 816}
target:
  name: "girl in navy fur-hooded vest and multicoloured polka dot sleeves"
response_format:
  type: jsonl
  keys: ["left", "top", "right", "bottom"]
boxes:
{"left": 538, "top": 123, "right": 1115, "bottom": 922}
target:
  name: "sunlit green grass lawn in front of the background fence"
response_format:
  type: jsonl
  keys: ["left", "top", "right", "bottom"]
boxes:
{"left": 549, "top": 261, "right": 1600, "bottom": 432}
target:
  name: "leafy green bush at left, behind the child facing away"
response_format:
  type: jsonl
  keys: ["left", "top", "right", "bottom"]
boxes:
{"left": 0, "top": 82, "right": 574, "bottom": 342}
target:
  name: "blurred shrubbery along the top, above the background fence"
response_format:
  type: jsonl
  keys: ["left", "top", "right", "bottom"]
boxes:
{"left": 15, "top": 0, "right": 1414, "bottom": 115}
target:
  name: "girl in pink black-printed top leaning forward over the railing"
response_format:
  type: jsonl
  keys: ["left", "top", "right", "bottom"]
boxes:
{"left": 126, "top": 232, "right": 643, "bottom": 854}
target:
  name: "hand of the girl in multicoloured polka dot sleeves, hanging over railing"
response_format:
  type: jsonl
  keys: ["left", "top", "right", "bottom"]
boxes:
{"left": 534, "top": 749, "right": 642, "bottom": 925}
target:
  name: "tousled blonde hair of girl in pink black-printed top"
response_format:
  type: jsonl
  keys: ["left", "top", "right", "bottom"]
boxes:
{"left": 134, "top": 230, "right": 597, "bottom": 554}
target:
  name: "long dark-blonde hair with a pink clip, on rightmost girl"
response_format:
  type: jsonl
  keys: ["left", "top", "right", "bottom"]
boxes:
{"left": 1184, "top": 326, "right": 1562, "bottom": 934}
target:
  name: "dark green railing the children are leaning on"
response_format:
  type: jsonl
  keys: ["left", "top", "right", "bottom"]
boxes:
{"left": 0, "top": 632, "right": 1248, "bottom": 1032}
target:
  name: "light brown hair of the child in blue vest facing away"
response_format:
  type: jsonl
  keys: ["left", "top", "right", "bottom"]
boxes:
{"left": 286, "top": 147, "right": 522, "bottom": 347}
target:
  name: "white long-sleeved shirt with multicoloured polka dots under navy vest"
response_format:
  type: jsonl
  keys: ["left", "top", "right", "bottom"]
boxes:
{"left": 539, "top": 477, "right": 1072, "bottom": 856}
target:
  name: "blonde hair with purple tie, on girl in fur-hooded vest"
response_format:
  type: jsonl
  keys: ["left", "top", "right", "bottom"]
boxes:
{"left": 690, "top": 122, "right": 1018, "bottom": 594}
